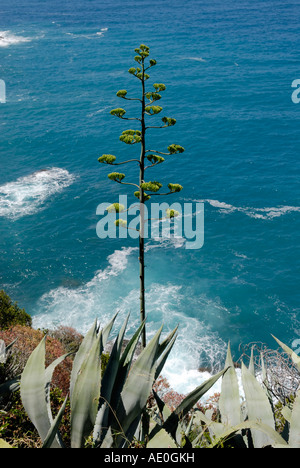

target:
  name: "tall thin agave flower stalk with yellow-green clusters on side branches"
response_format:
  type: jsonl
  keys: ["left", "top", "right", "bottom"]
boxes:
{"left": 99, "top": 44, "right": 184, "bottom": 348}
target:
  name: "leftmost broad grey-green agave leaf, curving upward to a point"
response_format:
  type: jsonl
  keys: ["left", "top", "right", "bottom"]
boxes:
{"left": 20, "top": 337, "right": 59, "bottom": 448}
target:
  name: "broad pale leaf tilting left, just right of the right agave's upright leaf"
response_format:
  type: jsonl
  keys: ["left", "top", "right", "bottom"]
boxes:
{"left": 242, "top": 364, "right": 275, "bottom": 448}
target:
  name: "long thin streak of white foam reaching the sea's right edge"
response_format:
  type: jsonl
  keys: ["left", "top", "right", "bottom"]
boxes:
{"left": 198, "top": 199, "right": 300, "bottom": 220}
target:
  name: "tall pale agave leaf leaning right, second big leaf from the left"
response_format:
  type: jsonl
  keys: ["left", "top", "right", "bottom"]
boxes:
{"left": 71, "top": 333, "right": 103, "bottom": 448}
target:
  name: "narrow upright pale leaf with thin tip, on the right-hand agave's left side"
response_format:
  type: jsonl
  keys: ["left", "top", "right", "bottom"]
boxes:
{"left": 219, "top": 344, "right": 241, "bottom": 426}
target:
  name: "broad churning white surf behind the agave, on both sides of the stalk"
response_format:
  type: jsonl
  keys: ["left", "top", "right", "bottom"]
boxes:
{"left": 33, "top": 247, "right": 227, "bottom": 396}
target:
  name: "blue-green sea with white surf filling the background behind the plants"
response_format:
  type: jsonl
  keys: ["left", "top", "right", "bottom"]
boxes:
{"left": 0, "top": 0, "right": 300, "bottom": 392}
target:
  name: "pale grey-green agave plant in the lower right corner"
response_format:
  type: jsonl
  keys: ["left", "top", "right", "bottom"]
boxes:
{"left": 189, "top": 337, "right": 300, "bottom": 448}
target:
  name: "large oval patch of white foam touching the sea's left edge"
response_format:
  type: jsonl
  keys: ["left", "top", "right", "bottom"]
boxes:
{"left": 0, "top": 167, "right": 75, "bottom": 219}
